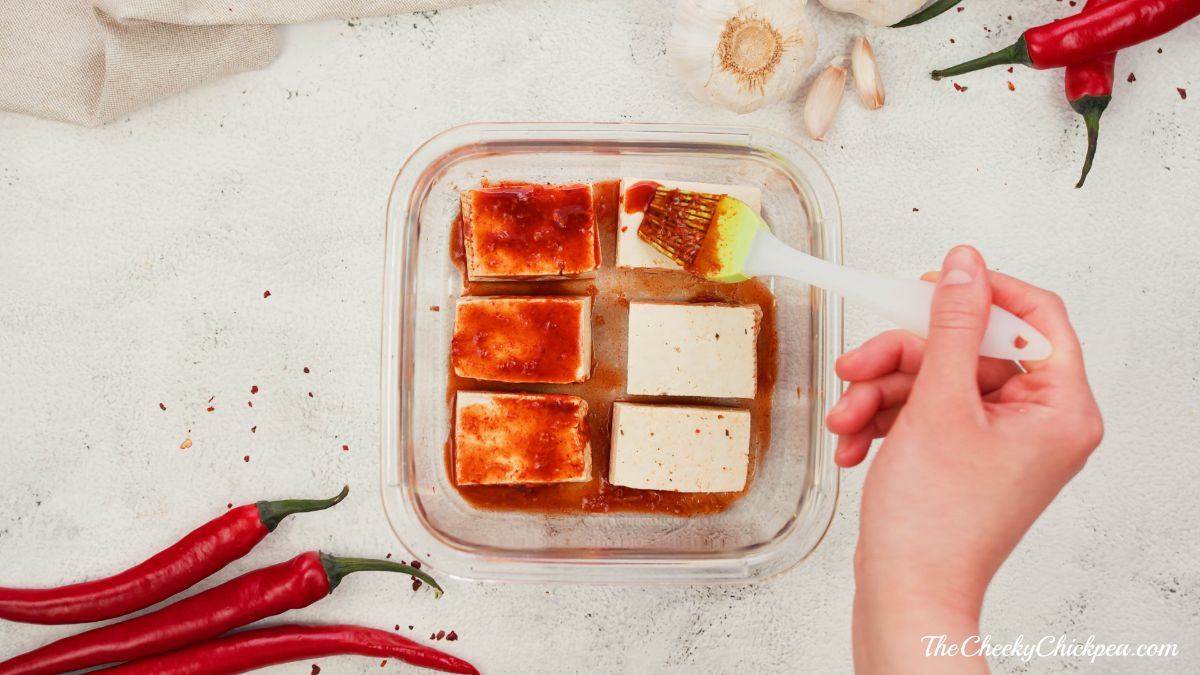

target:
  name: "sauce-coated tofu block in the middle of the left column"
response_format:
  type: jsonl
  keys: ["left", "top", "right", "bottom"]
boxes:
{"left": 450, "top": 295, "right": 592, "bottom": 384}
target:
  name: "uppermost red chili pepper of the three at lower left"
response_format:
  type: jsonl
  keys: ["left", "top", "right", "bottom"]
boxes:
{"left": 0, "top": 486, "right": 350, "bottom": 623}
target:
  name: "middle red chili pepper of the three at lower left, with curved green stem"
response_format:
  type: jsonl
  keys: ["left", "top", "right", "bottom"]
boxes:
{"left": 0, "top": 551, "right": 442, "bottom": 675}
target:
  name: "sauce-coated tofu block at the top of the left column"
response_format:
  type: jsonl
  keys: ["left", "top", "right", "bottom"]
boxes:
{"left": 460, "top": 184, "right": 600, "bottom": 281}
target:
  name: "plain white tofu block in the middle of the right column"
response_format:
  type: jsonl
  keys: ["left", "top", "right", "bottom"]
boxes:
{"left": 626, "top": 301, "right": 762, "bottom": 399}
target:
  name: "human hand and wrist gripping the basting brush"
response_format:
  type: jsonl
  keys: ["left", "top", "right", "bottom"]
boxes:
{"left": 826, "top": 246, "right": 1103, "bottom": 673}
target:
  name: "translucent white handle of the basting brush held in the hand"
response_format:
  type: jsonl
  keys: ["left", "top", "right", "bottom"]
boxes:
{"left": 743, "top": 229, "right": 1052, "bottom": 360}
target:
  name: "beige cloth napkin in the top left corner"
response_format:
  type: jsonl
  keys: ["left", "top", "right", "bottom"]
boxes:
{"left": 0, "top": 0, "right": 472, "bottom": 126}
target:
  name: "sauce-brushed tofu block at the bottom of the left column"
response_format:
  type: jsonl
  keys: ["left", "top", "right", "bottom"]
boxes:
{"left": 454, "top": 392, "right": 592, "bottom": 485}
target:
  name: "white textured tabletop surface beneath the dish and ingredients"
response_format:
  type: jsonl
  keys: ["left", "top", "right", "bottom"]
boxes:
{"left": 0, "top": 0, "right": 1200, "bottom": 674}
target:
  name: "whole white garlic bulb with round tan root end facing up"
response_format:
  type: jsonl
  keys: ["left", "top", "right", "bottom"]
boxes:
{"left": 667, "top": 0, "right": 817, "bottom": 113}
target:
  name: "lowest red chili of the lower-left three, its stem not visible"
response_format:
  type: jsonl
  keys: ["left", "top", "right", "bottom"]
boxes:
{"left": 102, "top": 626, "right": 479, "bottom": 675}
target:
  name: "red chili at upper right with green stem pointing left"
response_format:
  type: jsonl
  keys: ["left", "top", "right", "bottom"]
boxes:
{"left": 932, "top": 0, "right": 1200, "bottom": 79}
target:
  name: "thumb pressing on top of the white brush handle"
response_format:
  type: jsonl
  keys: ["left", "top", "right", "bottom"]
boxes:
{"left": 913, "top": 246, "right": 991, "bottom": 401}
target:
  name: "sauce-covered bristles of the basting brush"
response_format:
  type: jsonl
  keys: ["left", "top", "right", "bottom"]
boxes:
{"left": 637, "top": 186, "right": 721, "bottom": 267}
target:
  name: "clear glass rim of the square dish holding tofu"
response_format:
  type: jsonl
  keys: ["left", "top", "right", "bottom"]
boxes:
{"left": 379, "top": 123, "right": 842, "bottom": 584}
